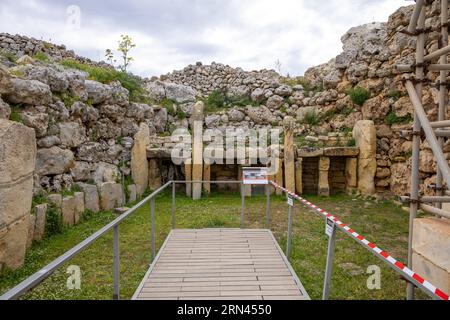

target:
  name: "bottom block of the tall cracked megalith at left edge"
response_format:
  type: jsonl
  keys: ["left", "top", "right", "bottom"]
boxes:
{"left": 0, "top": 215, "right": 30, "bottom": 271}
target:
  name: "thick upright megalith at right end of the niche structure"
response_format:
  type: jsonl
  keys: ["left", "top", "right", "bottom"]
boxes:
{"left": 353, "top": 120, "right": 377, "bottom": 195}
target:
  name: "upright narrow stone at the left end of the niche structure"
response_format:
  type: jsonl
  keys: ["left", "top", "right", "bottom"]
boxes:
{"left": 131, "top": 123, "right": 150, "bottom": 195}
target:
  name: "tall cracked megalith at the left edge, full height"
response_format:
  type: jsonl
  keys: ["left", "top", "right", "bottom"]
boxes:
{"left": 0, "top": 119, "right": 36, "bottom": 270}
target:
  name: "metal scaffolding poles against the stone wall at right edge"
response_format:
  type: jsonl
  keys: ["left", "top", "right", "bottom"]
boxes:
{"left": 397, "top": 0, "right": 450, "bottom": 300}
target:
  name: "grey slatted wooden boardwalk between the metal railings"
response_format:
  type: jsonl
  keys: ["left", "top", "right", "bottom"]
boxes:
{"left": 133, "top": 229, "right": 309, "bottom": 300}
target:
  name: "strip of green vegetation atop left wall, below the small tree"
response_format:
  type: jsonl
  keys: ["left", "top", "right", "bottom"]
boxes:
{"left": 61, "top": 59, "right": 149, "bottom": 103}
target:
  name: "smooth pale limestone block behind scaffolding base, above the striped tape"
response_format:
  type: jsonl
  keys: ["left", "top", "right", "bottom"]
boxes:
{"left": 413, "top": 218, "right": 450, "bottom": 272}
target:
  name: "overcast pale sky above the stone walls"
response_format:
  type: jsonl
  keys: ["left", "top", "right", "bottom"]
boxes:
{"left": 0, "top": 0, "right": 412, "bottom": 76}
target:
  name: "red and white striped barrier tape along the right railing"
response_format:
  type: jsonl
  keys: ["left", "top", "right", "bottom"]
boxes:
{"left": 271, "top": 181, "right": 450, "bottom": 300}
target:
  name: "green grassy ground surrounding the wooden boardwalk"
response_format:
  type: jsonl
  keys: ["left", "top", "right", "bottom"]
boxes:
{"left": 0, "top": 190, "right": 424, "bottom": 300}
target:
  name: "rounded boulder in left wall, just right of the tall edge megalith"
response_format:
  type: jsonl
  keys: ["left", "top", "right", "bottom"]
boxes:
{"left": 36, "top": 147, "right": 75, "bottom": 176}
